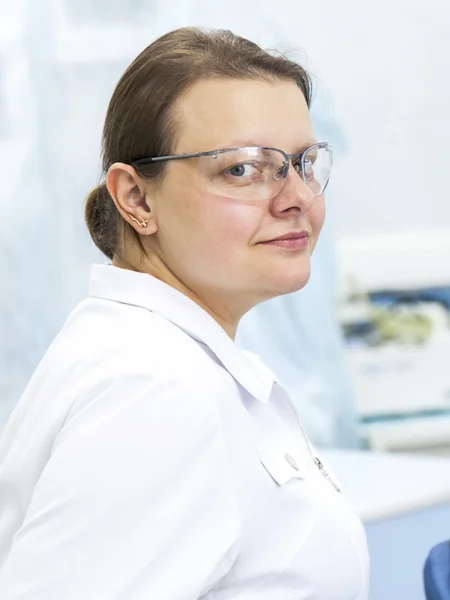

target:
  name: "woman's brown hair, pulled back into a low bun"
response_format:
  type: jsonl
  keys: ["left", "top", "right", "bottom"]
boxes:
{"left": 85, "top": 27, "right": 312, "bottom": 259}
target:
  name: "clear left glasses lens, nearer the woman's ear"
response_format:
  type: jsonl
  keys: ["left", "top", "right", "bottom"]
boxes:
{"left": 199, "top": 148, "right": 285, "bottom": 200}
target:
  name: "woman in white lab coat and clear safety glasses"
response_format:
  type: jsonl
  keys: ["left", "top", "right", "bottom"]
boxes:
{"left": 0, "top": 28, "right": 368, "bottom": 600}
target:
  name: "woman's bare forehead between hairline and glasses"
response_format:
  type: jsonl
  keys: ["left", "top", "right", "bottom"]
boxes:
{"left": 176, "top": 79, "right": 315, "bottom": 153}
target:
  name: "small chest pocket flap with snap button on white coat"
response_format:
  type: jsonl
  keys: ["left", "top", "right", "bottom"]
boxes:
{"left": 256, "top": 431, "right": 313, "bottom": 485}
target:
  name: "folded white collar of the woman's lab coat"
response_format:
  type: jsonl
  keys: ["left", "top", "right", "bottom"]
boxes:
{"left": 89, "top": 265, "right": 274, "bottom": 404}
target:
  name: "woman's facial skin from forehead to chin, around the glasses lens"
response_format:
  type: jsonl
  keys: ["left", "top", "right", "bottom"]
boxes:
{"left": 146, "top": 79, "right": 325, "bottom": 311}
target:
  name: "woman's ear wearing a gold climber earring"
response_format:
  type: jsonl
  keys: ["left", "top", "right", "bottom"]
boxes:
{"left": 106, "top": 163, "right": 158, "bottom": 235}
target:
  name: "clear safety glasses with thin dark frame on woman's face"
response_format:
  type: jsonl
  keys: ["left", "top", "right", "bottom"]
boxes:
{"left": 131, "top": 142, "right": 333, "bottom": 200}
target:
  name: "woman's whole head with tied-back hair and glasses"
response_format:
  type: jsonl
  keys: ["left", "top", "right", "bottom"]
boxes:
{"left": 86, "top": 28, "right": 329, "bottom": 328}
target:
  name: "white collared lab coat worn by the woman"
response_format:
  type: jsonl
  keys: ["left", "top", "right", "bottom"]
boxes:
{"left": 0, "top": 265, "right": 368, "bottom": 600}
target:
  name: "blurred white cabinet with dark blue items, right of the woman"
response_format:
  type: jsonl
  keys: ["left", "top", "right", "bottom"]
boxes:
{"left": 339, "top": 230, "right": 450, "bottom": 454}
